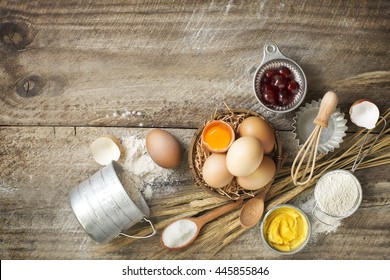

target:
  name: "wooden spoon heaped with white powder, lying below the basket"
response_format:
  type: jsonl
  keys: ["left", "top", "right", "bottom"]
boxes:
{"left": 160, "top": 199, "right": 244, "bottom": 250}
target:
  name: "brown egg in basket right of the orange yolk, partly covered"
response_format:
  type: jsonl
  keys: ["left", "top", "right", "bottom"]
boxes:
{"left": 238, "top": 117, "right": 275, "bottom": 154}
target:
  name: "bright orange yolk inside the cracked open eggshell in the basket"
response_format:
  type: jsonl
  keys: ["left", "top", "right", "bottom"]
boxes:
{"left": 204, "top": 123, "right": 232, "bottom": 150}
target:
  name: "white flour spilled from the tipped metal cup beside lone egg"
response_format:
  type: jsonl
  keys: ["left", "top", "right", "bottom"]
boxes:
{"left": 121, "top": 135, "right": 173, "bottom": 200}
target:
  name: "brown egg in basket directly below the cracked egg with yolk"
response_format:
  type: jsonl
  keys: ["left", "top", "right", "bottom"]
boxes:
{"left": 202, "top": 154, "right": 234, "bottom": 189}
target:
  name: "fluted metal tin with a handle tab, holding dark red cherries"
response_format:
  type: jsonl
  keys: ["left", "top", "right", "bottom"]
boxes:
{"left": 253, "top": 42, "right": 307, "bottom": 113}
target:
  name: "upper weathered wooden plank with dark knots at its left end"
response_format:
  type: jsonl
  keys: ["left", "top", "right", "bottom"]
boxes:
{"left": 0, "top": 0, "right": 390, "bottom": 130}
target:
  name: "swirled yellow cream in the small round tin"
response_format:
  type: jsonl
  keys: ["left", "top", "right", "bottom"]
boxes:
{"left": 263, "top": 207, "right": 308, "bottom": 252}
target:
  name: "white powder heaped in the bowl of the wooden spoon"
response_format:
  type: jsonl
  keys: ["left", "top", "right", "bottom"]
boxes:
{"left": 162, "top": 219, "right": 198, "bottom": 248}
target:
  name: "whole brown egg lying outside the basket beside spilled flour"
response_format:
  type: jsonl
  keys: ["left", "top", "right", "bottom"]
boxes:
{"left": 146, "top": 128, "right": 181, "bottom": 168}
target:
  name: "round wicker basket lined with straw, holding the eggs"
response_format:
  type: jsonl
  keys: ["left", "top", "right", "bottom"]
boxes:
{"left": 188, "top": 109, "right": 283, "bottom": 200}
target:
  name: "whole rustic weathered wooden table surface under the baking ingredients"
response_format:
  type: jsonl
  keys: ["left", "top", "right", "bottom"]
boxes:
{"left": 0, "top": 0, "right": 390, "bottom": 259}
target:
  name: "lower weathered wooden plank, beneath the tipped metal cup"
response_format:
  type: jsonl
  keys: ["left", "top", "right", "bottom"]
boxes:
{"left": 0, "top": 127, "right": 390, "bottom": 259}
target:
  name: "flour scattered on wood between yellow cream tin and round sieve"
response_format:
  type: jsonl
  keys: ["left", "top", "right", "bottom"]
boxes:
{"left": 289, "top": 188, "right": 340, "bottom": 242}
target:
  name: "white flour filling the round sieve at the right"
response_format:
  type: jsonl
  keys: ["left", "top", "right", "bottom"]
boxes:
{"left": 315, "top": 171, "right": 359, "bottom": 217}
